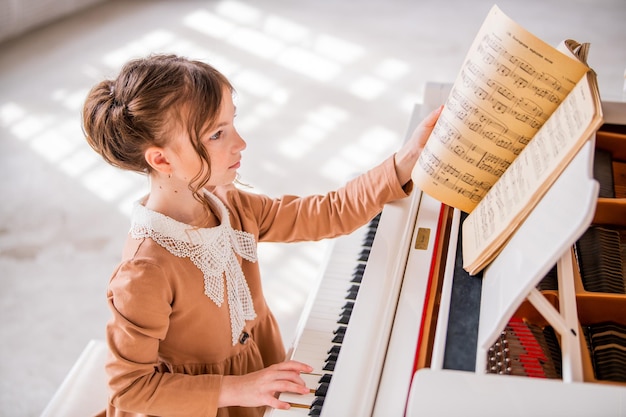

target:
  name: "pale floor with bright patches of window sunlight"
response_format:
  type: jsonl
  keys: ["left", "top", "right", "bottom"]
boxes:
{"left": 0, "top": 0, "right": 626, "bottom": 417}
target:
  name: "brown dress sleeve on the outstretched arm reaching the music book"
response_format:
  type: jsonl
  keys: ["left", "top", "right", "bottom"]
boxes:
{"left": 242, "top": 157, "right": 412, "bottom": 242}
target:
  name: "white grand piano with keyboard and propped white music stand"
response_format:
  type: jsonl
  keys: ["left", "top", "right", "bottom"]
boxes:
{"left": 266, "top": 84, "right": 626, "bottom": 417}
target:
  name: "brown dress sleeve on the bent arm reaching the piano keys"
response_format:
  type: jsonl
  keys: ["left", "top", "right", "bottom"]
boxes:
{"left": 106, "top": 260, "right": 222, "bottom": 417}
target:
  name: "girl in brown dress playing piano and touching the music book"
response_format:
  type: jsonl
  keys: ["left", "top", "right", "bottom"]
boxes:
{"left": 83, "top": 55, "right": 440, "bottom": 417}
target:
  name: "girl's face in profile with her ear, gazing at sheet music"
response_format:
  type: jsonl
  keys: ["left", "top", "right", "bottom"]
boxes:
{"left": 171, "top": 90, "right": 246, "bottom": 188}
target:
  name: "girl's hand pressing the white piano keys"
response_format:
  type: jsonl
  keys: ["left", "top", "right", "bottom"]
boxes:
{"left": 218, "top": 361, "right": 313, "bottom": 410}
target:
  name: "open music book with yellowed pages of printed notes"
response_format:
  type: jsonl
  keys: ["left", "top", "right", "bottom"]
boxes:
{"left": 412, "top": 6, "right": 602, "bottom": 275}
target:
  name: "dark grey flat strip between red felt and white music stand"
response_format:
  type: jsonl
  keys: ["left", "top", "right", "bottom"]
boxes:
{"left": 443, "top": 213, "right": 482, "bottom": 371}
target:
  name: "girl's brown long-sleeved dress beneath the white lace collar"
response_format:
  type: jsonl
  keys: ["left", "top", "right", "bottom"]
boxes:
{"left": 106, "top": 154, "right": 411, "bottom": 417}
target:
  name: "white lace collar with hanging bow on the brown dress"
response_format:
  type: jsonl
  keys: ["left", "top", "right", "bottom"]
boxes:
{"left": 130, "top": 191, "right": 257, "bottom": 346}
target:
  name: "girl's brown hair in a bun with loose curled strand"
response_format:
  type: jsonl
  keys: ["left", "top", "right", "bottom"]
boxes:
{"left": 83, "top": 55, "right": 232, "bottom": 205}
